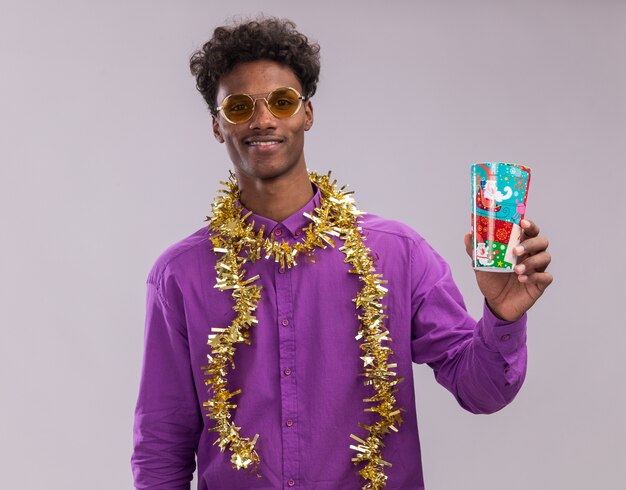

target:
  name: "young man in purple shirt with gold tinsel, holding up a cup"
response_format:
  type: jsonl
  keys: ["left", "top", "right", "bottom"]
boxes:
{"left": 132, "top": 19, "right": 552, "bottom": 490}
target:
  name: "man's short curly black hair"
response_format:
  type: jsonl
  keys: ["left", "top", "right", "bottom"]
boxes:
{"left": 189, "top": 17, "right": 320, "bottom": 114}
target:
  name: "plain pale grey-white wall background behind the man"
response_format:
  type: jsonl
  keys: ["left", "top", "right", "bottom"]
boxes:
{"left": 0, "top": 0, "right": 626, "bottom": 490}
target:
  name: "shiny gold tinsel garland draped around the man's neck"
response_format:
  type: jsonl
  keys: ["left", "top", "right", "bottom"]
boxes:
{"left": 202, "top": 172, "right": 402, "bottom": 490}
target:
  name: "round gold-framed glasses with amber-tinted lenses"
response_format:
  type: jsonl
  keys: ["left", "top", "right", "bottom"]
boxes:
{"left": 215, "top": 87, "right": 306, "bottom": 124}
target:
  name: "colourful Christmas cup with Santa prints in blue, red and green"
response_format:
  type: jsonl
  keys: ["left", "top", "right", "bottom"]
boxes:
{"left": 471, "top": 162, "right": 530, "bottom": 272}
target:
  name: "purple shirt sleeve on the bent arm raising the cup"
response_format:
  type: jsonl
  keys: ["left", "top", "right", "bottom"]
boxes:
{"left": 411, "top": 237, "right": 527, "bottom": 413}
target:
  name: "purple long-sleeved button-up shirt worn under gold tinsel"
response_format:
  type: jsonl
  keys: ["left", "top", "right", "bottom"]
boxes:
{"left": 132, "top": 186, "right": 526, "bottom": 490}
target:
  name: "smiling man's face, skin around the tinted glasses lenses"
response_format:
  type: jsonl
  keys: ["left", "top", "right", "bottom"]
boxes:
{"left": 213, "top": 60, "right": 313, "bottom": 184}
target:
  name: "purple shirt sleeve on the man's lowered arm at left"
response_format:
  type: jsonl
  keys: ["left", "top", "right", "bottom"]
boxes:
{"left": 131, "top": 266, "right": 202, "bottom": 490}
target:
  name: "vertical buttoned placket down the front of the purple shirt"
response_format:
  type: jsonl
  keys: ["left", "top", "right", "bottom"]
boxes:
{"left": 273, "top": 238, "right": 300, "bottom": 488}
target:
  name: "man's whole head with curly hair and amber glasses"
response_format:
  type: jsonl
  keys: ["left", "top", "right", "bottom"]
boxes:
{"left": 191, "top": 18, "right": 320, "bottom": 185}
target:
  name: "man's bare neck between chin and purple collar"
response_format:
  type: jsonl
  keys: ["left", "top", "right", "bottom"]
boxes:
{"left": 237, "top": 165, "right": 313, "bottom": 222}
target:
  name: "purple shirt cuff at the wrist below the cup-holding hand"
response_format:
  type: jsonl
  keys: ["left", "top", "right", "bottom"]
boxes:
{"left": 479, "top": 301, "right": 527, "bottom": 358}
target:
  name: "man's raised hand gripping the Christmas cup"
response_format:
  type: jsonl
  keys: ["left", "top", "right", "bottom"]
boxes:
{"left": 465, "top": 219, "right": 552, "bottom": 322}
